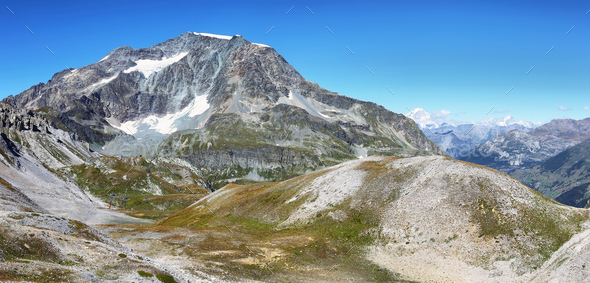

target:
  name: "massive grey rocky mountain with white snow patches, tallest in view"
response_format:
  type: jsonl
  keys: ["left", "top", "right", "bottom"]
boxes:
{"left": 5, "top": 32, "right": 444, "bottom": 187}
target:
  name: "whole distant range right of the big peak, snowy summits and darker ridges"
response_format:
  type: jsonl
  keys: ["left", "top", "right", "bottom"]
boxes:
{"left": 406, "top": 108, "right": 590, "bottom": 212}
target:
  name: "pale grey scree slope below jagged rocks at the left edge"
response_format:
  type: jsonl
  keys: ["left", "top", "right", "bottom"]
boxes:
{"left": 0, "top": 100, "right": 155, "bottom": 226}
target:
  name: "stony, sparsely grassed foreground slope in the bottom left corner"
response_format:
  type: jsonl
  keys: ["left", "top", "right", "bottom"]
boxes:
{"left": 0, "top": 211, "right": 219, "bottom": 282}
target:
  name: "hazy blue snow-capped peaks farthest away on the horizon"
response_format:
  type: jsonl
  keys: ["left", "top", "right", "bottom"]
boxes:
{"left": 406, "top": 108, "right": 540, "bottom": 158}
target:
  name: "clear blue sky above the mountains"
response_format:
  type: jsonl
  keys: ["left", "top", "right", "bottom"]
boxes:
{"left": 0, "top": 0, "right": 590, "bottom": 122}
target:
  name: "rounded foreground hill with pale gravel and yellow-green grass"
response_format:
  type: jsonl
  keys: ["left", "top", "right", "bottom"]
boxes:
{"left": 157, "top": 158, "right": 588, "bottom": 279}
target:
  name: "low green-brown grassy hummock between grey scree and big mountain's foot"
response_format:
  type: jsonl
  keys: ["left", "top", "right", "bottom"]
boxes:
{"left": 61, "top": 156, "right": 209, "bottom": 219}
